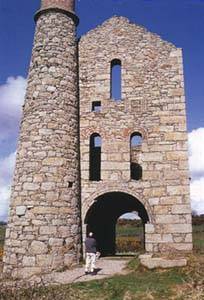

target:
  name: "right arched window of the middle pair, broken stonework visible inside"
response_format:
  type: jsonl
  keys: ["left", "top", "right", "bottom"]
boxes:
{"left": 130, "top": 132, "right": 142, "bottom": 180}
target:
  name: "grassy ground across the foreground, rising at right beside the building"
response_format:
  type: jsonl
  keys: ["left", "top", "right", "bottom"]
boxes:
{"left": 0, "top": 218, "right": 204, "bottom": 300}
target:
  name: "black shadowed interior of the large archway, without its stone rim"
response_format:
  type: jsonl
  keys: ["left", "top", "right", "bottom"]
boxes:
{"left": 85, "top": 192, "right": 149, "bottom": 256}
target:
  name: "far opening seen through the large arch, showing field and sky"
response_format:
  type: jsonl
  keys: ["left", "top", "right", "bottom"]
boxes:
{"left": 115, "top": 211, "right": 144, "bottom": 255}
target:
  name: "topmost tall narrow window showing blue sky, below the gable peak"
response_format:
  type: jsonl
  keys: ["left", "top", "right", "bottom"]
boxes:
{"left": 110, "top": 59, "right": 122, "bottom": 101}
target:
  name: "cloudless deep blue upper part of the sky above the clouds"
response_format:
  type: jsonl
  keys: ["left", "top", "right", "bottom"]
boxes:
{"left": 0, "top": 0, "right": 204, "bottom": 131}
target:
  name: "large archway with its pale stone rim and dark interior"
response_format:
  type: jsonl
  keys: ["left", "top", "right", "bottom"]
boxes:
{"left": 83, "top": 188, "right": 152, "bottom": 255}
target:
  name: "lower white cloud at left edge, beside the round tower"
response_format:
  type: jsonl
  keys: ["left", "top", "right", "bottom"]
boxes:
{"left": 0, "top": 153, "right": 16, "bottom": 221}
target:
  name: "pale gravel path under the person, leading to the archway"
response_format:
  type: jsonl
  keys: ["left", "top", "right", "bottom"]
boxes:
{"left": 42, "top": 258, "right": 129, "bottom": 285}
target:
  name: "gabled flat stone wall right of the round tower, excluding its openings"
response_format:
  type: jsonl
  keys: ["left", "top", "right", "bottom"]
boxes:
{"left": 79, "top": 17, "right": 192, "bottom": 253}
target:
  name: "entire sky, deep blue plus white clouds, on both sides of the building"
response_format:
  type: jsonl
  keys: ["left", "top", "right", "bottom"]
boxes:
{"left": 0, "top": 0, "right": 204, "bottom": 218}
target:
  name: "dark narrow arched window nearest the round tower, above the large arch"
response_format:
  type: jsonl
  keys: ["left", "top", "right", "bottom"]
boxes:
{"left": 89, "top": 133, "right": 101, "bottom": 181}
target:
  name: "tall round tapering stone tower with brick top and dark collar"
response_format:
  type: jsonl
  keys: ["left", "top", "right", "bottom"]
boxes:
{"left": 4, "top": 0, "right": 81, "bottom": 278}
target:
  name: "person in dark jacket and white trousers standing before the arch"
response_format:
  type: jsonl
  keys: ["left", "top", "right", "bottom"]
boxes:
{"left": 85, "top": 232, "right": 97, "bottom": 275}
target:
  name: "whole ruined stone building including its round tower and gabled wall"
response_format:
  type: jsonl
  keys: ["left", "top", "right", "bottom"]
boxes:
{"left": 4, "top": 0, "right": 192, "bottom": 277}
